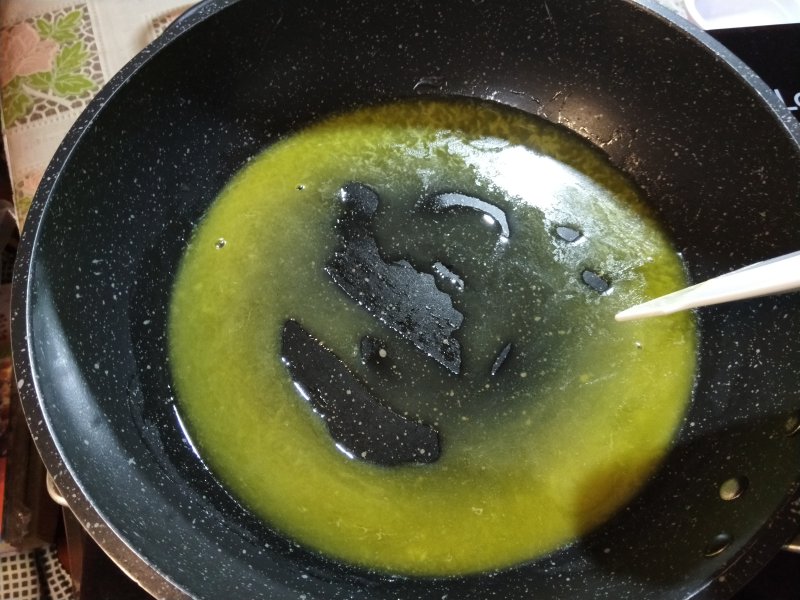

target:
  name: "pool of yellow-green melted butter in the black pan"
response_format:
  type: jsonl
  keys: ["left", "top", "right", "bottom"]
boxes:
{"left": 169, "top": 101, "right": 695, "bottom": 576}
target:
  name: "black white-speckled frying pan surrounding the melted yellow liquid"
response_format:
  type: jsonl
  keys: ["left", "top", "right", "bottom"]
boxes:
{"left": 13, "top": 0, "right": 800, "bottom": 600}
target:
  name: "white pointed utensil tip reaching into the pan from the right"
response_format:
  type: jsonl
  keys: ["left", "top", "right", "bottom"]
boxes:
{"left": 615, "top": 252, "right": 800, "bottom": 321}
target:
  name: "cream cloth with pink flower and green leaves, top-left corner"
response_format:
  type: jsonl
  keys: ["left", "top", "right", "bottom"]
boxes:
{"left": 0, "top": 0, "right": 193, "bottom": 227}
